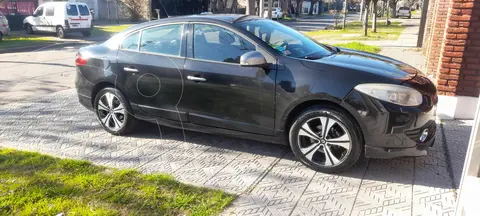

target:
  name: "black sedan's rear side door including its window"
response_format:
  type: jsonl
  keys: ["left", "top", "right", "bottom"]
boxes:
{"left": 117, "top": 24, "right": 186, "bottom": 120}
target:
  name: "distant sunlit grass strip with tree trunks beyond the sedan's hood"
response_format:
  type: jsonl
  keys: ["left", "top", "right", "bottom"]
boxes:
{"left": 305, "top": 22, "right": 405, "bottom": 41}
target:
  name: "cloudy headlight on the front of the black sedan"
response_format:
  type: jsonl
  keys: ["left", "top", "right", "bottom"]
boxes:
{"left": 355, "top": 83, "right": 422, "bottom": 106}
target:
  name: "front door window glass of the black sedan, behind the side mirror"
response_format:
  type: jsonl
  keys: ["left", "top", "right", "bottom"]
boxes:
{"left": 193, "top": 24, "right": 255, "bottom": 63}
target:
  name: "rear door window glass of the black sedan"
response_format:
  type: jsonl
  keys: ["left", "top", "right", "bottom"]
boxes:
{"left": 140, "top": 24, "right": 183, "bottom": 56}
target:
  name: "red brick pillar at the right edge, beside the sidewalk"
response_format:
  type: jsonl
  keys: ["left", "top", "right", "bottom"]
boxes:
{"left": 436, "top": 0, "right": 480, "bottom": 97}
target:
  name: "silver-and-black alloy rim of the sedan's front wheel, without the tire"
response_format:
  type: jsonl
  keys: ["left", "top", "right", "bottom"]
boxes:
{"left": 298, "top": 116, "right": 352, "bottom": 167}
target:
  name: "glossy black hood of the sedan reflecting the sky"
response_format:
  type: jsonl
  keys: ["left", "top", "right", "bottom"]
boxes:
{"left": 305, "top": 48, "right": 419, "bottom": 81}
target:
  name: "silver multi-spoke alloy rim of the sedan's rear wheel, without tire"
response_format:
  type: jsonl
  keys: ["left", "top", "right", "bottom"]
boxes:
{"left": 97, "top": 92, "right": 126, "bottom": 131}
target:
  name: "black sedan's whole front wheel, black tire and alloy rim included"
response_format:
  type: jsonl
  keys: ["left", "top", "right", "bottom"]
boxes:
{"left": 289, "top": 106, "right": 363, "bottom": 173}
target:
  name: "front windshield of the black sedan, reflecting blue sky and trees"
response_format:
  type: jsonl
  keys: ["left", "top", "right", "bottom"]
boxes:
{"left": 236, "top": 19, "right": 335, "bottom": 59}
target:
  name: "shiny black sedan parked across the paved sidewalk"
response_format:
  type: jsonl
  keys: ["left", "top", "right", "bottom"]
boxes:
{"left": 76, "top": 15, "right": 437, "bottom": 172}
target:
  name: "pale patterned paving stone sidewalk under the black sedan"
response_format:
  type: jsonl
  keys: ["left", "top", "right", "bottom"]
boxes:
{"left": 0, "top": 89, "right": 473, "bottom": 216}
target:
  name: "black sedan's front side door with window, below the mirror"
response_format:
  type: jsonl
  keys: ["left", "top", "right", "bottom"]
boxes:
{"left": 180, "top": 23, "right": 276, "bottom": 135}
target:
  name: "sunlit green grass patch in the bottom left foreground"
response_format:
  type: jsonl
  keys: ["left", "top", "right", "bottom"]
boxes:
{"left": 0, "top": 149, "right": 235, "bottom": 215}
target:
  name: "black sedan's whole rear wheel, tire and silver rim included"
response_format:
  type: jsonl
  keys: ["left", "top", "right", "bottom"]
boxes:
{"left": 93, "top": 87, "right": 138, "bottom": 135}
